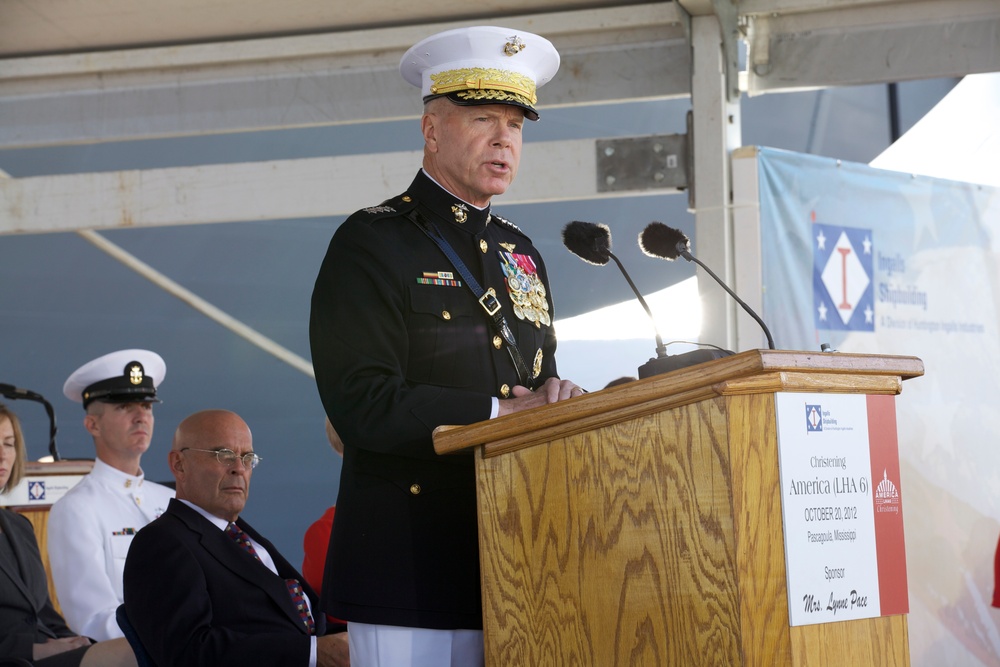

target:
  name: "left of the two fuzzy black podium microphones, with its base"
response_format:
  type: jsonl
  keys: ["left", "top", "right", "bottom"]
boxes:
{"left": 563, "top": 221, "right": 732, "bottom": 379}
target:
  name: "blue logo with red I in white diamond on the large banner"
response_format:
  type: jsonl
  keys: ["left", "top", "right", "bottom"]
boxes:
{"left": 812, "top": 224, "right": 875, "bottom": 331}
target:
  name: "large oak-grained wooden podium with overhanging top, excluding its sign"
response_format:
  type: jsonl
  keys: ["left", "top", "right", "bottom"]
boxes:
{"left": 434, "top": 350, "right": 923, "bottom": 667}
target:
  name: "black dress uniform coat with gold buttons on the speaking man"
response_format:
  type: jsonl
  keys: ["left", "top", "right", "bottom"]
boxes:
{"left": 309, "top": 171, "right": 556, "bottom": 629}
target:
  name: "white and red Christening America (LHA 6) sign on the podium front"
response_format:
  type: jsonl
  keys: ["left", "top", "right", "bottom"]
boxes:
{"left": 775, "top": 393, "right": 908, "bottom": 626}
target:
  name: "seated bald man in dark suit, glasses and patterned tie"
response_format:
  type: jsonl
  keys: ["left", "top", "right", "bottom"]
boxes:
{"left": 124, "top": 410, "right": 349, "bottom": 667}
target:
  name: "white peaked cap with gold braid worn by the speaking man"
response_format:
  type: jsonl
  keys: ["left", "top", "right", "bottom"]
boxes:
{"left": 399, "top": 26, "right": 559, "bottom": 120}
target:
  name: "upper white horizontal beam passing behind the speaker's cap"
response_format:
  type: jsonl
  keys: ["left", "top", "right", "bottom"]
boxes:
{"left": 0, "top": 3, "right": 690, "bottom": 149}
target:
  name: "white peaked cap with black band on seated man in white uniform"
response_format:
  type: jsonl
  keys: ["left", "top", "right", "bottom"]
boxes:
{"left": 63, "top": 350, "right": 167, "bottom": 408}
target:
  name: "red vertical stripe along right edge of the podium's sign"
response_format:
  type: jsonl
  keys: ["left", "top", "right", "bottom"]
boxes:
{"left": 867, "top": 395, "right": 910, "bottom": 616}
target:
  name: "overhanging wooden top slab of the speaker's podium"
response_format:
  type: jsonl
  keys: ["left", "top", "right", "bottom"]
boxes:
{"left": 434, "top": 350, "right": 924, "bottom": 454}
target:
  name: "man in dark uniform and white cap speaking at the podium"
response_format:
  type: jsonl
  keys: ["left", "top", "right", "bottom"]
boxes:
{"left": 310, "top": 27, "right": 583, "bottom": 667}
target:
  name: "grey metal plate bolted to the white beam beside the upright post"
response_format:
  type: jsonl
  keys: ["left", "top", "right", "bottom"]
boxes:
{"left": 596, "top": 134, "right": 690, "bottom": 192}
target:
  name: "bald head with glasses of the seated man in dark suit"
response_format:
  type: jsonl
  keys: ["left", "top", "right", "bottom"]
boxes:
{"left": 168, "top": 410, "right": 253, "bottom": 521}
